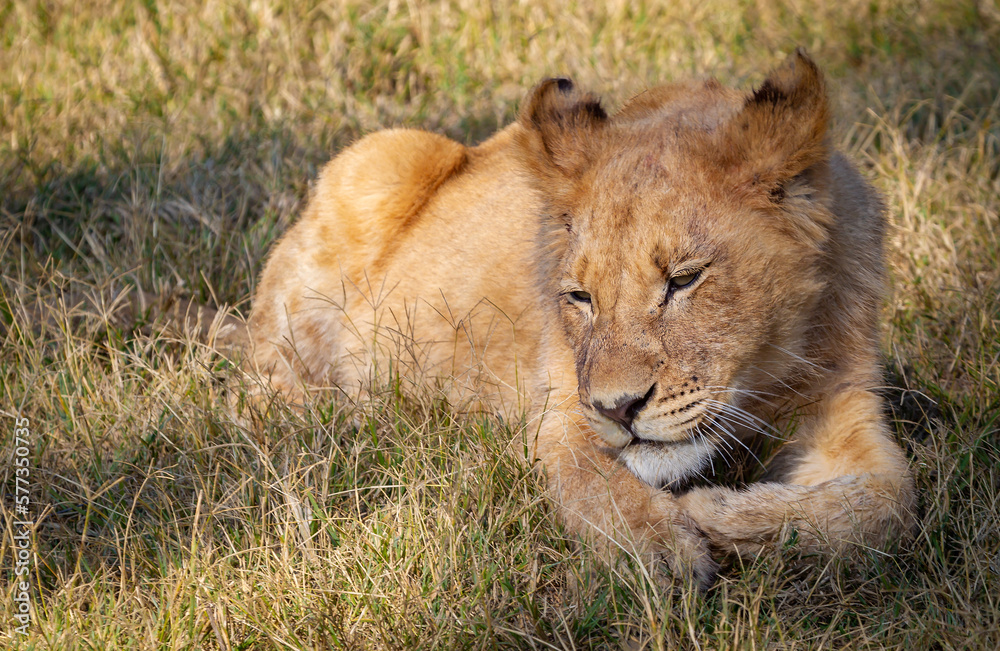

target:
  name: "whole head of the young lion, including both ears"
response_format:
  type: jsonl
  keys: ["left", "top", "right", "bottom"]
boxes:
{"left": 519, "top": 52, "right": 833, "bottom": 485}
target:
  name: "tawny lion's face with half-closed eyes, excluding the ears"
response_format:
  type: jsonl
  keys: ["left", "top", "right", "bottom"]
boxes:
{"left": 558, "top": 161, "right": 818, "bottom": 484}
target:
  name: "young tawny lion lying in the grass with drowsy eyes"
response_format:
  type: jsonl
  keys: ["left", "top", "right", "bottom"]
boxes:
{"left": 249, "top": 50, "right": 915, "bottom": 585}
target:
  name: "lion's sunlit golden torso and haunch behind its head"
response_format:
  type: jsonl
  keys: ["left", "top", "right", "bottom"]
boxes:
{"left": 251, "top": 123, "right": 542, "bottom": 402}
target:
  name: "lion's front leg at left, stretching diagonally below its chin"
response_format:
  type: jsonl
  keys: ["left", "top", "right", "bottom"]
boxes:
{"left": 536, "top": 412, "right": 718, "bottom": 588}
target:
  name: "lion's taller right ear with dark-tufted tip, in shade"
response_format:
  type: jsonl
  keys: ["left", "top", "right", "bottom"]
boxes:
{"left": 720, "top": 48, "right": 830, "bottom": 197}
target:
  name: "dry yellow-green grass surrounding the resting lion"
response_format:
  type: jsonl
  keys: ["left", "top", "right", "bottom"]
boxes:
{"left": 0, "top": 0, "right": 1000, "bottom": 651}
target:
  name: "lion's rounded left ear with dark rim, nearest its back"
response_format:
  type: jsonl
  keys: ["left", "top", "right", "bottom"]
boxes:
{"left": 518, "top": 77, "right": 608, "bottom": 178}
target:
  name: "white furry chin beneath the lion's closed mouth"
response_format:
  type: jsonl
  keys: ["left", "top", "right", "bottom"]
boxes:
{"left": 618, "top": 436, "right": 715, "bottom": 488}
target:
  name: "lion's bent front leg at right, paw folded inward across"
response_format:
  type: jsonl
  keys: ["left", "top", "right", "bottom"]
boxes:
{"left": 678, "top": 389, "right": 914, "bottom": 557}
